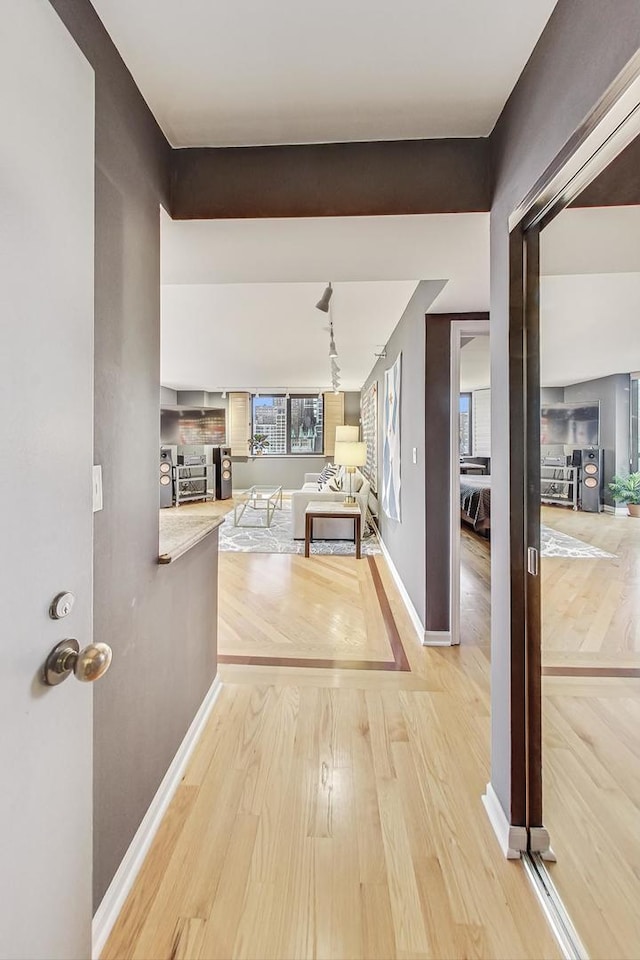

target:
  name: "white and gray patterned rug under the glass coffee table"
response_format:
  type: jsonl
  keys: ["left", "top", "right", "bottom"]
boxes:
{"left": 220, "top": 500, "right": 381, "bottom": 556}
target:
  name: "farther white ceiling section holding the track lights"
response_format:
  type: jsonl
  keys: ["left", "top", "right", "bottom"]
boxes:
{"left": 161, "top": 280, "right": 441, "bottom": 392}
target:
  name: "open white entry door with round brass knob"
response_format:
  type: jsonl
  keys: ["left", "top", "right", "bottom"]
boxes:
{"left": 0, "top": 0, "right": 94, "bottom": 960}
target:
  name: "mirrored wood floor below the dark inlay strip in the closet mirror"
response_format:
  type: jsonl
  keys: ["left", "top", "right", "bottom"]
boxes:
{"left": 543, "top": 677, "right": 640, "bottom": 960}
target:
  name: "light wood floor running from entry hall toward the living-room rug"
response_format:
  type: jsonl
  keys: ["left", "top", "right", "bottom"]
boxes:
{"left": 103, "top": 554, "right": 559, "bottom": 960}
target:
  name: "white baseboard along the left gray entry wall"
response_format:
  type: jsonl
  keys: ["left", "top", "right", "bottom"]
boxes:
{"left": 92, "top": 676, "right": 222, "bottom": 960}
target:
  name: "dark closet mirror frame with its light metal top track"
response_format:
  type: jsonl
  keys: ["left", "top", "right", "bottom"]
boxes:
{"left": 509, "top": 56, "right": 640, "bottom": 858}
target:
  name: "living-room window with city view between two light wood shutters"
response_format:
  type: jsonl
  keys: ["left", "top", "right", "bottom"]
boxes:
{"left": 251, "top": 396, "right": 324, "bottom": 457}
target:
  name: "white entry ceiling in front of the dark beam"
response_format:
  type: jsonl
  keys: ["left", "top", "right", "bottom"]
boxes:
{"left": 92, "top": 0, "right": 556, "bottom": 147}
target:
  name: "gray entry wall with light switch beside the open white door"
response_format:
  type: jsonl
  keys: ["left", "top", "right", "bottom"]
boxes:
{"left": 51, "top": 0, "right": 217, "bottom": 907}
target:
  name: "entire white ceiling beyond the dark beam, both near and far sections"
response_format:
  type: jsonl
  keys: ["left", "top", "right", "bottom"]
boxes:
{"left": 161, "top": 213, "right": 489, "bottom": 391}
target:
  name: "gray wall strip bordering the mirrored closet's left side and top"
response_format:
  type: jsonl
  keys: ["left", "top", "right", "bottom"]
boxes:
{"left": 490, "top": 0, "right": 640, "bottom": 819}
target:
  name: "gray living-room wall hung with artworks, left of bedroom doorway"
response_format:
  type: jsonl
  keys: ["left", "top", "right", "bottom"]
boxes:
{"left": 362, "top": 280, "right": 446, "bottom": 627}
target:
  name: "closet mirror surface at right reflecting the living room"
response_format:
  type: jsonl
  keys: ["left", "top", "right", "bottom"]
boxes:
{"left": 540, "top": 141, "right": 640, "bottom": 958}
